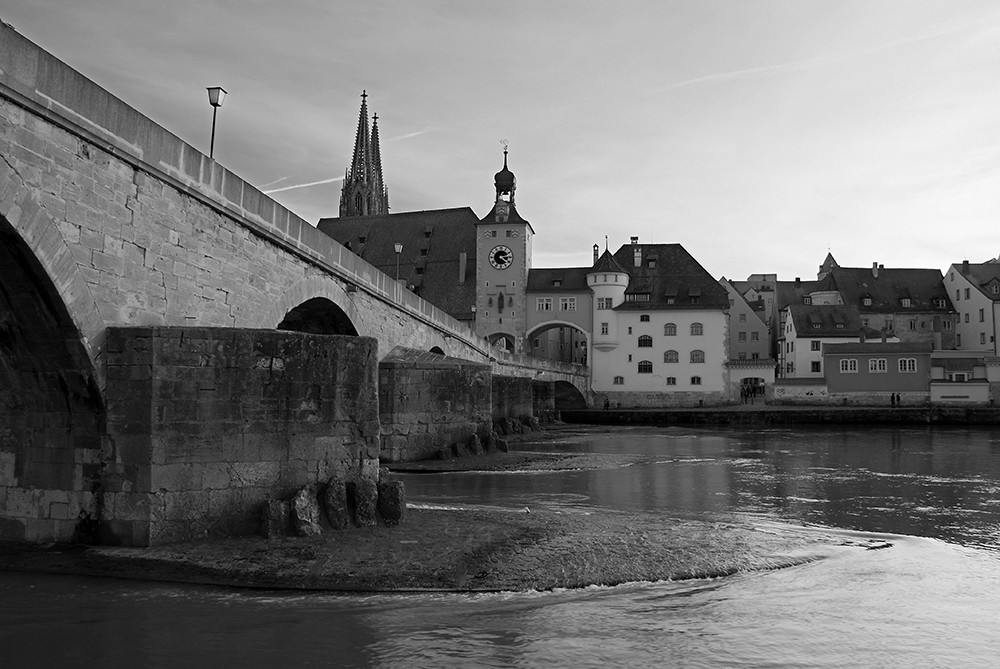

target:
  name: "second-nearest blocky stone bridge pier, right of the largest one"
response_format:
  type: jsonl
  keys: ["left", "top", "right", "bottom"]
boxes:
{"left": 379, "top": 349, "right": 491, "bottom": 462}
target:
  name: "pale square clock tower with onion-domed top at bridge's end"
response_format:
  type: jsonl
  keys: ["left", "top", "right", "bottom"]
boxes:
{"left": 476, "top": 148, "right": 535, "bottom": 353}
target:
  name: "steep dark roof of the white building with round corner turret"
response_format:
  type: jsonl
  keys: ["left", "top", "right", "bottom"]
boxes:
{"left": 598, "top": 244, "right": 729, "bottom": 309}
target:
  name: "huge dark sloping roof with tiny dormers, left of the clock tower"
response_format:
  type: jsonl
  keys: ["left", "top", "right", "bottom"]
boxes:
{"left": 317, "top": 207, "right": 479, "bottom": 320}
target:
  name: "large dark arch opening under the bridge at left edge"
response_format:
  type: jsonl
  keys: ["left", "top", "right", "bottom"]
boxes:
{"left": 0, "top": 217, "right": 106, "bottom": 543}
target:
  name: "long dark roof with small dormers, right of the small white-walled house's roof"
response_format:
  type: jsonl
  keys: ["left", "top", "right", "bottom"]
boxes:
{"left": 830, "top": 267, "right": 954, "bottom": 313}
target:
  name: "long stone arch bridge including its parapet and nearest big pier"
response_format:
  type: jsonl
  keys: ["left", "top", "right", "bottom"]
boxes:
{"left": 0, "top": 26, "right": 587, "bottom": 544}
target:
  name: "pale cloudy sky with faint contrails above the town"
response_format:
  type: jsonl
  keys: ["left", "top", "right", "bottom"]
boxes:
{"left": 0, "top": 0, "right": 1000, "bottom": 280}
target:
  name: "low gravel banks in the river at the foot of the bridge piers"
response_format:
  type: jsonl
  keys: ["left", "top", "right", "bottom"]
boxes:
{"left": 0, "top": 430, "right": 836, "bottom": 592}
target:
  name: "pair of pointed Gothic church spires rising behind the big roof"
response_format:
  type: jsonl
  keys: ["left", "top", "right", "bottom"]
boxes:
{"left": 340, "top": 91, "right": 389, "bottom": 218}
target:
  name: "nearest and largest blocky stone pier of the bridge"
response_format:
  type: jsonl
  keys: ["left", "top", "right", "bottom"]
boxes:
{"left": 101, "top": 327, "right": 379, "bottom": 546}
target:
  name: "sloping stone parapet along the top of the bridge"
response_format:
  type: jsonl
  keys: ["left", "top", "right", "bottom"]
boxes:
{"left": 0, "top": 24, "right": 489, "bottom": 362}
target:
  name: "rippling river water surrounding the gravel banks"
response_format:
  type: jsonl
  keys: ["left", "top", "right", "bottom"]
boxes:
{"left": 0, "top": 428, "right": 1000, "bottom": 668}
